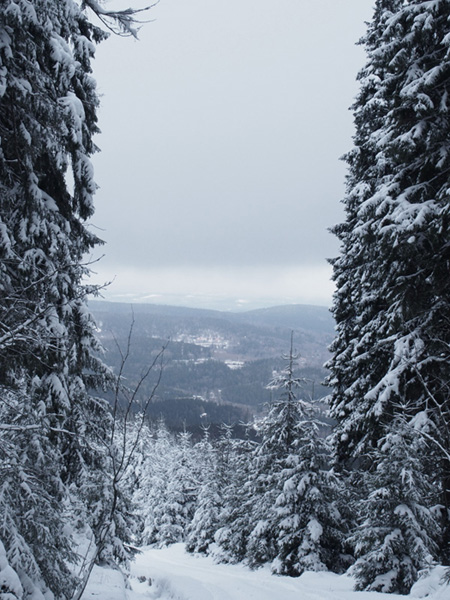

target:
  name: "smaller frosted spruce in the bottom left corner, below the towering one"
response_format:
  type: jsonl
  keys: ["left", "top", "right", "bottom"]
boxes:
{"left": 0, "top": 387, "right": 75, "bottom": 599}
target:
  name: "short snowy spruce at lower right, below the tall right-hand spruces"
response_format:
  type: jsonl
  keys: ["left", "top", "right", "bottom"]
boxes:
{"left": 351, "top": 422, "right": 439, "bottom": 594}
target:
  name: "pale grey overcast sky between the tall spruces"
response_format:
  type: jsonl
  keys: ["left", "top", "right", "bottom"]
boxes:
{"left": 88, "top": 0, "right": 373, "bottom": 309}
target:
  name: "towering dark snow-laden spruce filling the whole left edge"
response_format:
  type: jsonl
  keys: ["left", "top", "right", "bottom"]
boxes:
{"left": 0, "top": 0, "right": 150, "bottom": 598}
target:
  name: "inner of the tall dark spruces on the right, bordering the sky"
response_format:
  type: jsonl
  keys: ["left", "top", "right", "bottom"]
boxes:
{"left": 329, "top": 0, "right": 410, "bottom": 468}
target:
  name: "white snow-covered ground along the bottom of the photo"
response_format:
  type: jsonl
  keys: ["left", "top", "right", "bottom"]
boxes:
{"left": 82, "top": 544, "right": 450, "bottom": 600}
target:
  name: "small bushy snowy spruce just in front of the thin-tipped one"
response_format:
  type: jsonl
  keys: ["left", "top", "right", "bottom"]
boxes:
{"left": 272, "top": 400, "right": 348, "bottom": 577}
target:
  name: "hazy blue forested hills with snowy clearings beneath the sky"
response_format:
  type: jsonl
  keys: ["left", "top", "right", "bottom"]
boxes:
{"left": 90, "top": 301, "right": 333, "bottom": 429}
